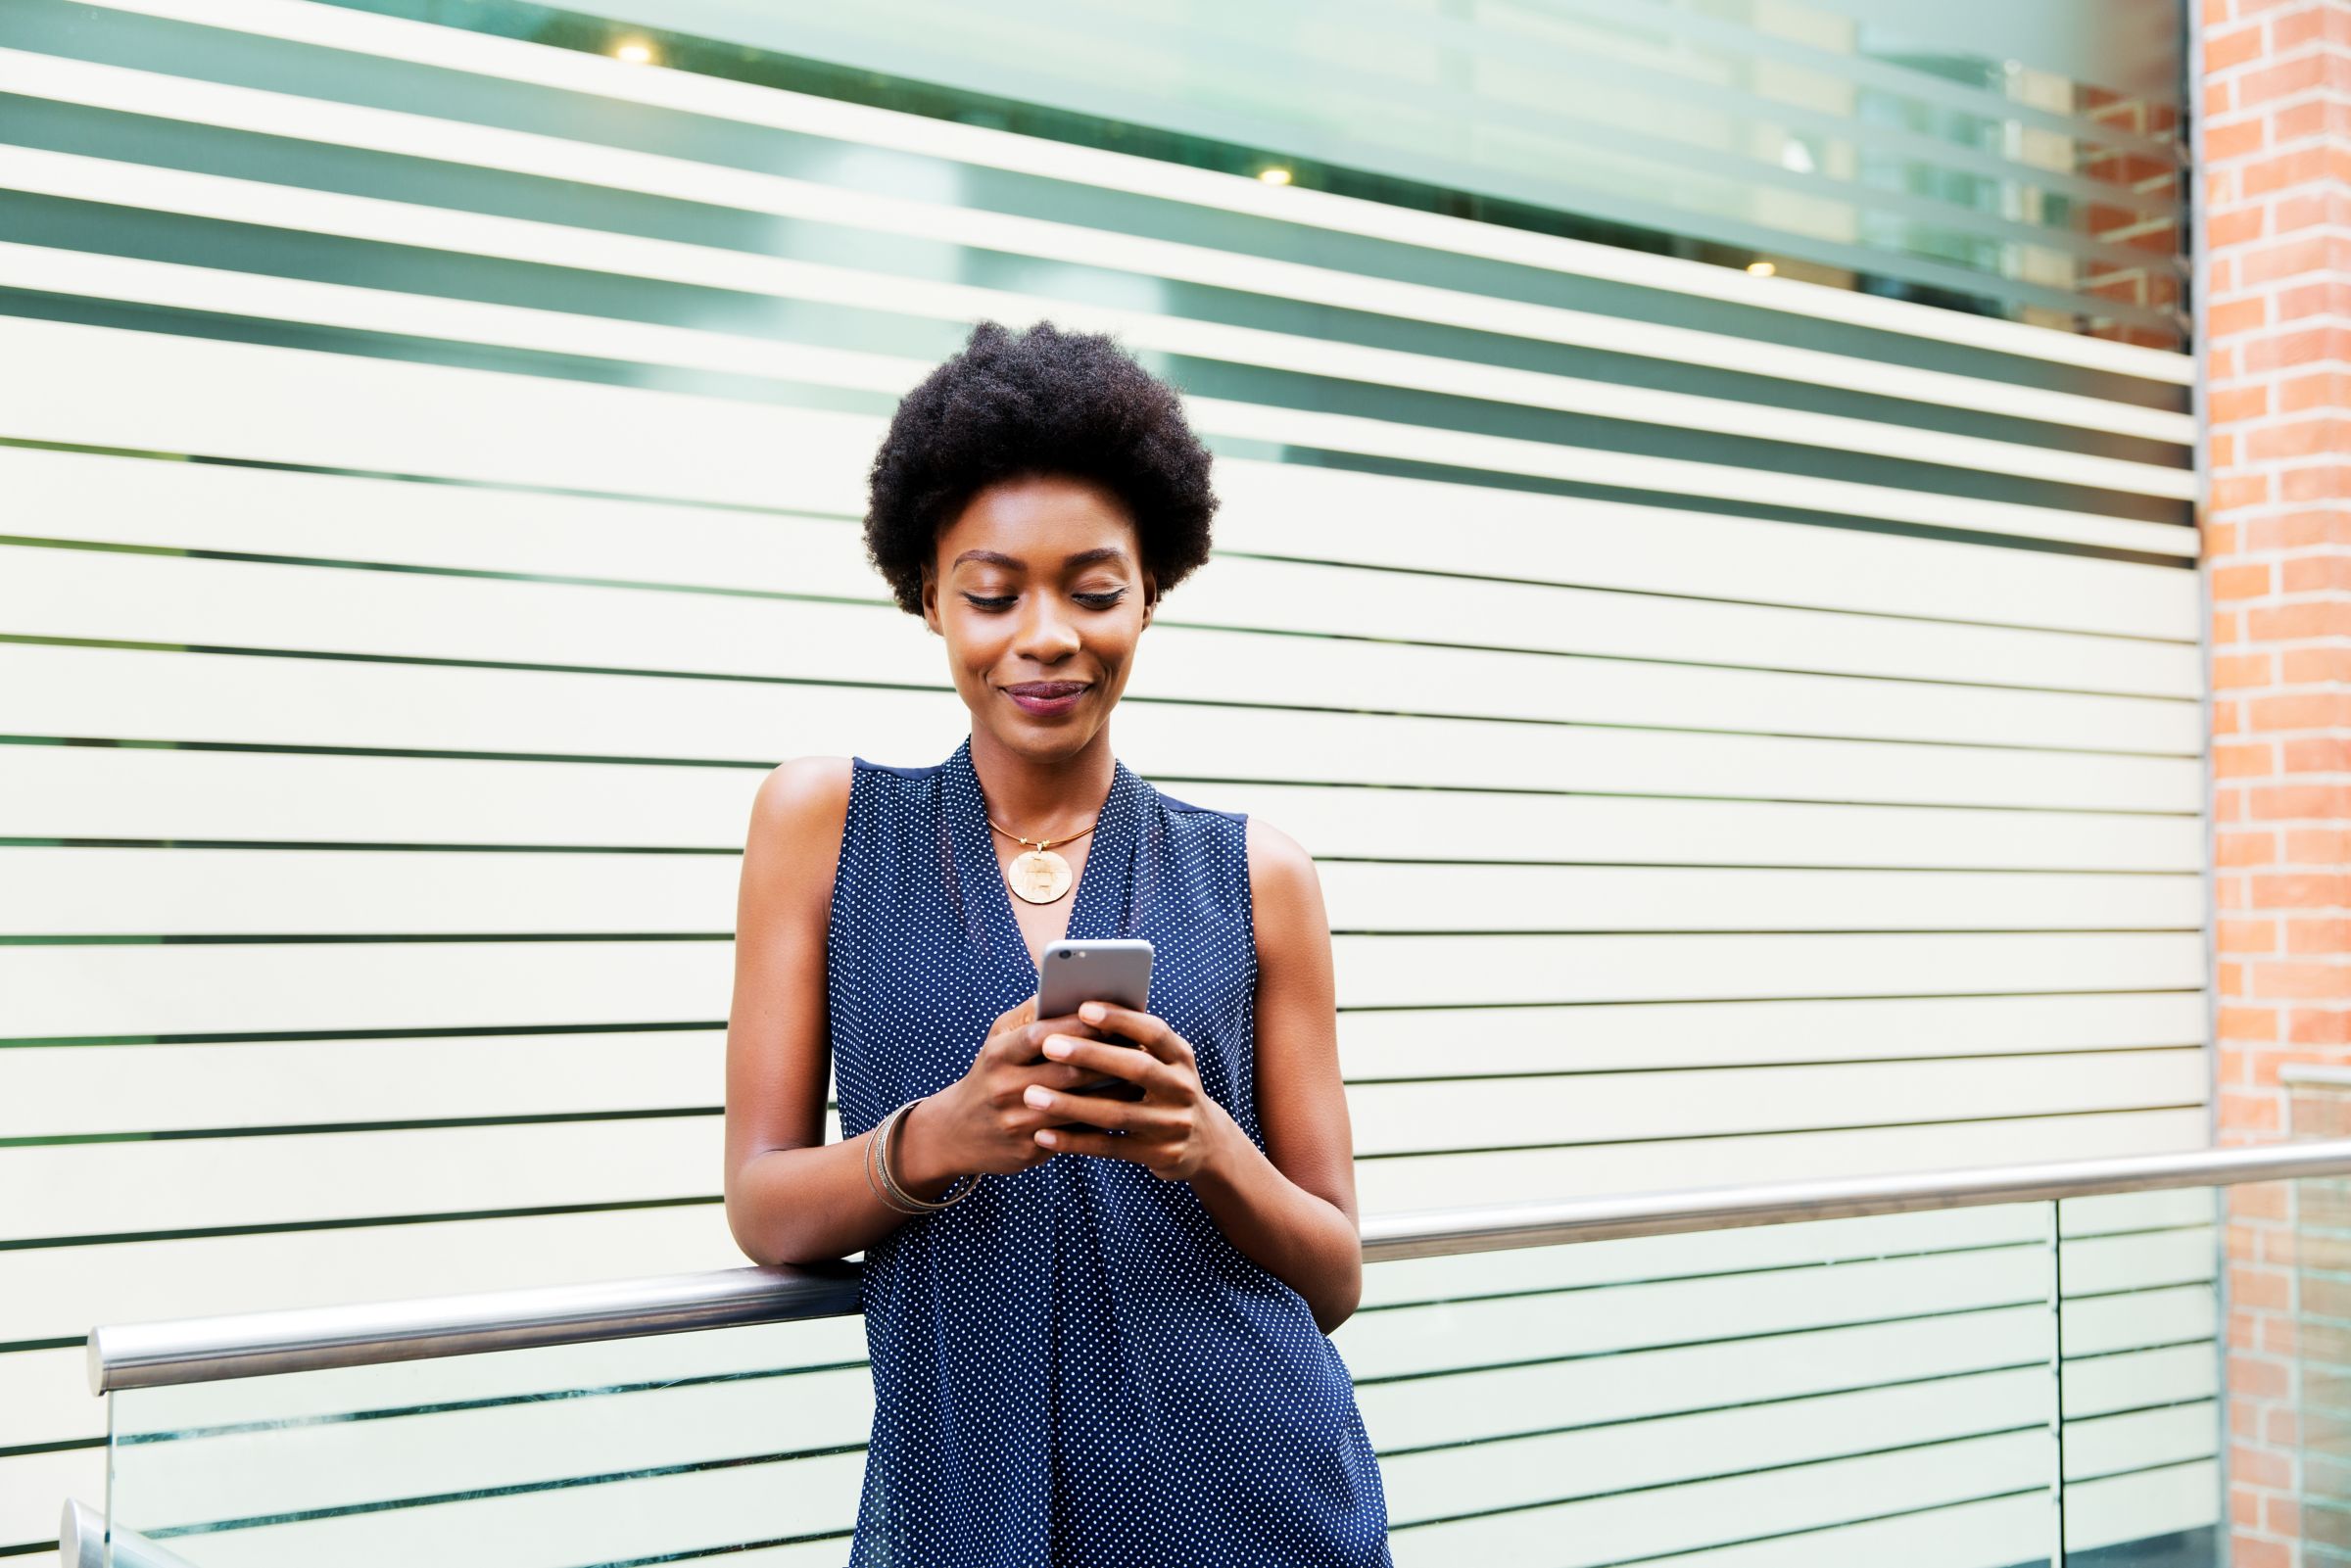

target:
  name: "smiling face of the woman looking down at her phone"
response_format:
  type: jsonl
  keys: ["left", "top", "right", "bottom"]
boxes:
{"left": 922, "top": 475, "right": 1157, "bottom": 762}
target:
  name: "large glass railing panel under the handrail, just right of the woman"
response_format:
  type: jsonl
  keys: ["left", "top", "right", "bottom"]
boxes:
{"left": 1335, "top": 1204, "right": 2057, "bottom": 1568}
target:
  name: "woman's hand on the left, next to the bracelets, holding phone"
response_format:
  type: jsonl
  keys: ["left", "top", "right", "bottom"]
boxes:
{"left": 891, "top": 997, "right": 1103, "bottom": 1192}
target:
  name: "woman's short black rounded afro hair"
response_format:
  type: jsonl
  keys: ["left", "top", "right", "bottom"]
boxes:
{"left": 865, "top": 322, "right": 1216, "bottom": 616}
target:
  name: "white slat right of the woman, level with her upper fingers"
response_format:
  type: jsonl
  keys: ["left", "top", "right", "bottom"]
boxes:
{"left": 1340, "top": 992, "right": 2203, "bottom": 1081}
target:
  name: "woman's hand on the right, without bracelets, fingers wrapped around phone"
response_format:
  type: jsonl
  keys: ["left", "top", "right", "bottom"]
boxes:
{"left": 1028, "top": 1002, "right": 1241, "bottom": 1182}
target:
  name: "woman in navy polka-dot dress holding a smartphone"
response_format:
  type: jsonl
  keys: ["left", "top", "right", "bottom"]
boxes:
{"left": 727, "top": 322, "right": 1392, "bottom": 1568}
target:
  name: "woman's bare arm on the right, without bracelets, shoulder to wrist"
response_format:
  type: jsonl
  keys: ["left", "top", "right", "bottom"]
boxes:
{"left": 1192, "top": 818, "right": 1364, "bottom": 1333}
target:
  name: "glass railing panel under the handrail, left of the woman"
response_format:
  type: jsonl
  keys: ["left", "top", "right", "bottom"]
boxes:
{"left": 108, "top": 1316, "right": 872, "bottom": 1568}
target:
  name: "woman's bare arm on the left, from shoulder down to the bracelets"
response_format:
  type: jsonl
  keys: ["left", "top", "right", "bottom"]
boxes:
{"left": 724, "top": 757, "right": 938, "bottom": 1262}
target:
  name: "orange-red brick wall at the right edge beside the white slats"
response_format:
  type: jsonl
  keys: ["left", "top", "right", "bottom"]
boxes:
{"left": 2198, "top": 0, "right": 2351, "bottom": 1568}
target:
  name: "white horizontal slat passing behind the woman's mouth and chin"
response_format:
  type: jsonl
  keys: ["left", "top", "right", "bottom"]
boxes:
{"left": 0, "top": 644, "right": 2200, "bottom": 814}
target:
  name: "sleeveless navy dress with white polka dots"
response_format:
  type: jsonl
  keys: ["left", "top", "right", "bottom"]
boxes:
{"left": 825, "top": 736, "right": 1394, "bottom": 1568}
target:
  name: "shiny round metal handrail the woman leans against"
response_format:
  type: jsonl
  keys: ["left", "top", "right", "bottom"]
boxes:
{"left": 89, "top": 1138, "right": 2351, "bottom": 1394}
